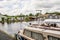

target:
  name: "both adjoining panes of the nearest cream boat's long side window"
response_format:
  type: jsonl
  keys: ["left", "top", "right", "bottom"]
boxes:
{"left": 24, "top": 30, "right": 44, "bottom": 40}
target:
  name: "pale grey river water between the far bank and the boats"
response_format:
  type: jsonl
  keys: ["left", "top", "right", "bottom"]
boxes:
{"left": 0, "top": 21, "right": 38, "bottom": 35}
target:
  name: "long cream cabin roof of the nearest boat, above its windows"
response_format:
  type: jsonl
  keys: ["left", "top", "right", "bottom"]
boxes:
{"left": 25, "top": 27, "right": 60, "bottom": 35}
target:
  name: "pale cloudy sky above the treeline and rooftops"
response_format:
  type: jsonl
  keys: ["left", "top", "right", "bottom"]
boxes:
{"left": 0, "top": 0, "right": 60, "bottom": 15}
